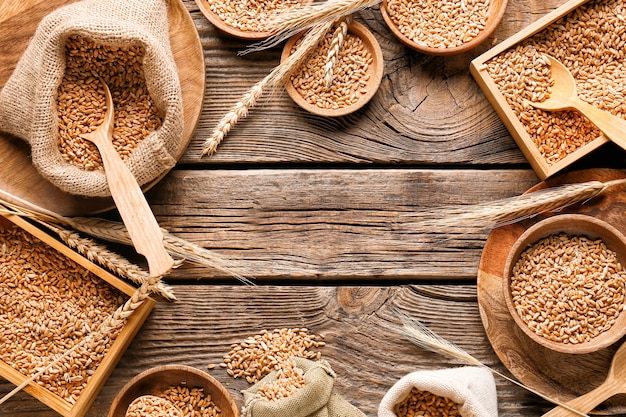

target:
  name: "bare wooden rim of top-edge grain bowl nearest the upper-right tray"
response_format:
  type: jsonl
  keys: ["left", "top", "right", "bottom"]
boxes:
{"left": 380, "top": 0, "right": 507, "bottom": 55}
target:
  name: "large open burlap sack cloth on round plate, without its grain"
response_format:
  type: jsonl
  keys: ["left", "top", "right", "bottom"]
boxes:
{"left": 0, "top": 0, "right": 183, "bottom": 197}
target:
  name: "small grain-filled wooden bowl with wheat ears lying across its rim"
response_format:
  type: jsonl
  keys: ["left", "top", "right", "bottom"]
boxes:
{"left": 281, "top": 22, "right": 384, "bottom": 117}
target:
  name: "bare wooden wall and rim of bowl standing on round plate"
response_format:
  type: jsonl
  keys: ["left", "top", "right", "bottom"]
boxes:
{"left": 502, "top": 214, "right": 626, "bottom": 354}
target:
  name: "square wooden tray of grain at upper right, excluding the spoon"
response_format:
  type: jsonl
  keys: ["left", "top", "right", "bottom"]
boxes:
{"left": 470, "top": 0, "right": 626, "bottom": 179}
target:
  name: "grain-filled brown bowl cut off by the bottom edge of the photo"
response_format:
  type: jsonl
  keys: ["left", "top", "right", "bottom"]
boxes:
{"left": 108, "top": 365, "right": 239, "bottom": 417}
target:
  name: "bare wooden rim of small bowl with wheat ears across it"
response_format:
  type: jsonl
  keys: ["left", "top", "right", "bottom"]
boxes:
{"left": 281, "top": 22, "right": 384, "bottom": 117}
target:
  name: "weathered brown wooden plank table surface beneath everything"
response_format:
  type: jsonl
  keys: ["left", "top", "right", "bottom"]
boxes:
{"left": 0, "top": 0, "right": 624, "bottom": 417}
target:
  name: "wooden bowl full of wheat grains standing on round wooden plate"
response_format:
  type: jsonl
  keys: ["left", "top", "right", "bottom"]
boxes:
{"left": 502, "top": 214, "right": 626, "bottom": 354}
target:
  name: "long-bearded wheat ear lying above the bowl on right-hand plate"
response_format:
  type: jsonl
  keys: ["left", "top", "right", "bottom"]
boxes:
{"left": 407, "top": 179, "right": 626, "bottom": 228}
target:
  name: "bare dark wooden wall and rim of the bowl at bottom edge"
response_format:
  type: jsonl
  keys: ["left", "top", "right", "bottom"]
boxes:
{"left": 108, "top": 365, "right": 239, "bottom": 417}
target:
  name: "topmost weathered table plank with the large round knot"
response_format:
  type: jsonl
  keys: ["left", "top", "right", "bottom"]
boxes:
{"left": 181, "top": 0, "right": 576, "bottom": 166}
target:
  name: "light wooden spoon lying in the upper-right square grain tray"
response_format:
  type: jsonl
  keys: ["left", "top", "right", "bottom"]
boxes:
{"left": 526, "top": 55, "right": 626, "bottom": 149}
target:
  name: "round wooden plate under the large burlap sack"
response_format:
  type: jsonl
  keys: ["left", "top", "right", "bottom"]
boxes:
{"left": 0, "top": 0, "right": 205, "bottom": 216}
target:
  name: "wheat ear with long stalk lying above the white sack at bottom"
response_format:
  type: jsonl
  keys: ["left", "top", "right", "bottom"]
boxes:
{"left": 392, "top": 307, "right": 589, "bottom": 417}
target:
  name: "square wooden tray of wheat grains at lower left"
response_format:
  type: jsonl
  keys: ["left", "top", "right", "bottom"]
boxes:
{"left": 0, "top": 211, "right": 155, "bottom": 417}
